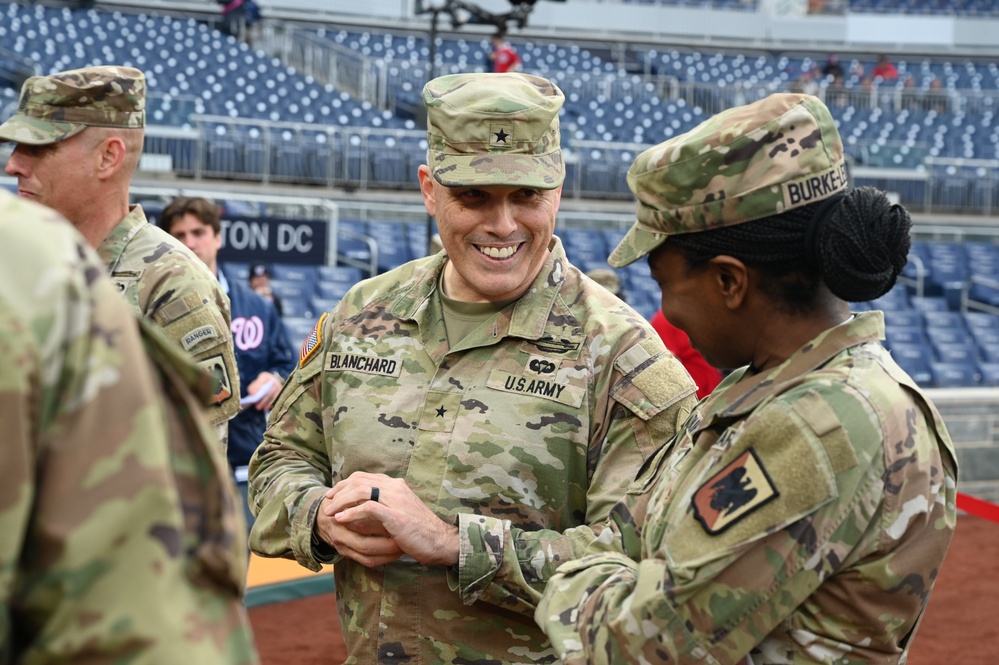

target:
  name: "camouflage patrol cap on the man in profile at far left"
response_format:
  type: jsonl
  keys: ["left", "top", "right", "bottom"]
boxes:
{"left": 0, "top": 66, "right": 146, "bottom": 145}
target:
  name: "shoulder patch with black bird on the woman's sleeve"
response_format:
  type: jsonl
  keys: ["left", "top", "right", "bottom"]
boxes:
{"left": 693, "top": 448, "right": 780, "bottom": 535}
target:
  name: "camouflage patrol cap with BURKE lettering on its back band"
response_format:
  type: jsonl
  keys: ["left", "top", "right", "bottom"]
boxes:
{"left": 608, "top": 93, "right": 847, "bottom": 268}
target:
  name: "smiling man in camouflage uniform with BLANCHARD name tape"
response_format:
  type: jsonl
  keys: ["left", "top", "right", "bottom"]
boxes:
{"left": 250, "top": 73, "right": 696, "bottom": 665}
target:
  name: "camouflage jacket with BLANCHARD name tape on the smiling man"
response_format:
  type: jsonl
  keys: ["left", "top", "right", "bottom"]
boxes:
{"left": 249, "top": 239, "right": 695, "bottom": 663}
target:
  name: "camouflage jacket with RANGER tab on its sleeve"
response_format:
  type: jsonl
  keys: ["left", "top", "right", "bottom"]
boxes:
{"left": 97, "top": 206, "right": 239, "bottom": 450}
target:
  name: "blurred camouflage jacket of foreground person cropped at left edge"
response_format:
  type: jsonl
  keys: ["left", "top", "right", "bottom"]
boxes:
{"left": 0, "top": 187, "right": 258, "bottom": 665}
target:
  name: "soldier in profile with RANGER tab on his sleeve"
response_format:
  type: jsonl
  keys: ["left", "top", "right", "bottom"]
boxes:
{"left": 0, "top": 66, "right": 239, "bottom": 449}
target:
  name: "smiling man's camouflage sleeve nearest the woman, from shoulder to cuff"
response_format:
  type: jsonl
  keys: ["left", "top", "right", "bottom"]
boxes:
{"left": 456, "top": 340, "right": 696, "bottom": 614}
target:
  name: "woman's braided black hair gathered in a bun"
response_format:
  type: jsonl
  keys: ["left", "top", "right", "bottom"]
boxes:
{"left": 668, "top": 187, "right": 912, "bottom": 313}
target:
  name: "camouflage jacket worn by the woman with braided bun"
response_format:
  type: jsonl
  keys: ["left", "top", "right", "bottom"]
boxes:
{"left": 535, "top": 312, "right": 957, "bottom": 665}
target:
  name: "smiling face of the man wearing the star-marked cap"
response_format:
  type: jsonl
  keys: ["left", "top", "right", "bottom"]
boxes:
{"left": 420, "top": 166, "right": 562, "bottom": 302}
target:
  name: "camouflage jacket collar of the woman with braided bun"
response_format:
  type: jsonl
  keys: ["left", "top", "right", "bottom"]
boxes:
{"left": 698, "top": 311, "right": 885, "bottom": 430}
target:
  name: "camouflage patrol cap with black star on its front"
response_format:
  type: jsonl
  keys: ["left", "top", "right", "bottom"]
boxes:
{"left": 423, "top": 73, "right": 565, "bottom": 189}
